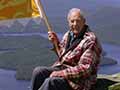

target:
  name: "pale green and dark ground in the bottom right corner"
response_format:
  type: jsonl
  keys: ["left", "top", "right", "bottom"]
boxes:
{"left": 95, "top": 73, "right": 120, "bottom": 90}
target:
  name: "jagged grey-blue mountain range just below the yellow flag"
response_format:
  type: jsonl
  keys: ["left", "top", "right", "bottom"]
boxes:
{"left": 0, "top": 18, "right": 47, "bottom": 34}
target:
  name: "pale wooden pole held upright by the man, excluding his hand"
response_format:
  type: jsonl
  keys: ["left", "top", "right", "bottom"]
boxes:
{"left": 35, "top": 0, "right": 60, "bottom": 56}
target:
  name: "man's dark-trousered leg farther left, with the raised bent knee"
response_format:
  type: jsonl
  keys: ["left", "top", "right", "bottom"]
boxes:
{"left": 31, "top": 67, "right": 58, "bottom": 90}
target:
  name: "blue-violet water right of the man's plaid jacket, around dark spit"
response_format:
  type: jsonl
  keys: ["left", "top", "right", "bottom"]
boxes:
{"left": 99, "top": 43, "right": 120, "bottom": 74}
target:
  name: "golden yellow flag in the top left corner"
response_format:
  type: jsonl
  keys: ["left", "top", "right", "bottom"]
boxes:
{"left": 0, "top": 0, "right": 41, "bottom": 20}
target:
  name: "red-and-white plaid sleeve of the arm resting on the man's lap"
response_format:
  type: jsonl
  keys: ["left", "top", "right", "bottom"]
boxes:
{"left": 62, "top": 41, "right": 100, "bottom": 78}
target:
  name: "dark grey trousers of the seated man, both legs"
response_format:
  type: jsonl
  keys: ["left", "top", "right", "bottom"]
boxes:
{"left": 31, "top": 67, "right": 72, "bottom": 90}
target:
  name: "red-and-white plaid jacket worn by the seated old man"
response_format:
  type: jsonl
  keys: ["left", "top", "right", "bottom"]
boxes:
{"left": 54, "top": 28, "right": 102, "bottom": 90}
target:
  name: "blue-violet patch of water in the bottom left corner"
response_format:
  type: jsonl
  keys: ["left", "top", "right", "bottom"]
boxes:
{"left": 0, "top": 69, "right": 30, "bottom": 90}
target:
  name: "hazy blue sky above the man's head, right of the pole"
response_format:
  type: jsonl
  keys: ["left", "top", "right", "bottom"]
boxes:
{"left": 41, "top": 0, "right": 120, "bottom": 16}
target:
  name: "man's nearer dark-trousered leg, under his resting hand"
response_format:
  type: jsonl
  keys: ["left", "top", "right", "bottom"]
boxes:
{"left": 38, "top": 77, "right": 72, "bottom": 90}
